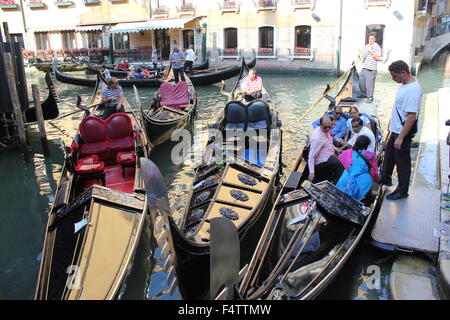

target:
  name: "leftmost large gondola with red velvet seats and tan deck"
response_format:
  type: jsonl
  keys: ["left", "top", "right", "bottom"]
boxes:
{"left": 35, "top": 74, "right": 149, "bottom": 300}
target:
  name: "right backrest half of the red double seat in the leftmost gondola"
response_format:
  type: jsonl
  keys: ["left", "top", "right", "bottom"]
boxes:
{"left": 105, "top": 113, "right": 134, "bottom": 152}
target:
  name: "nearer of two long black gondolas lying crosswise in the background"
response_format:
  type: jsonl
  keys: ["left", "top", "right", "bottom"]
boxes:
{"left": 53, "top": 58, "right": 256, "bottom": 88}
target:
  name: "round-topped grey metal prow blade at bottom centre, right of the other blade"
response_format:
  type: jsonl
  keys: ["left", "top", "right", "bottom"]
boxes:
{"left": 210, "top": 217, "right": 240, "bottom": 300}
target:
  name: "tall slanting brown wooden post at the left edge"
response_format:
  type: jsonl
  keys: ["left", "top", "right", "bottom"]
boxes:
{"left": 5, "top": 52, "right": 27, "bottom": 146}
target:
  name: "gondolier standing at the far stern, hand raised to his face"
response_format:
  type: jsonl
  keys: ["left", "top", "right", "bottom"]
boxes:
{"left": 358, "top": 33, "right": 381, "bottom": 103}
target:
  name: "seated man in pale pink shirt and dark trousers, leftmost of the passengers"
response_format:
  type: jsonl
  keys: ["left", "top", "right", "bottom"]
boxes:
{"left": 308, "top": 116, "right": 344, "bottom": 184}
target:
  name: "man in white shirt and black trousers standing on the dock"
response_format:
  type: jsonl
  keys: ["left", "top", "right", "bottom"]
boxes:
{"left": 380, "top": 60, "right": 422, "bottom": 200}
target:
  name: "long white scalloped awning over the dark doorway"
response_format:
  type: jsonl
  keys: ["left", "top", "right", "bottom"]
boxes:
{"left": 109, "top": 17, "right": 198, "bottom": 33}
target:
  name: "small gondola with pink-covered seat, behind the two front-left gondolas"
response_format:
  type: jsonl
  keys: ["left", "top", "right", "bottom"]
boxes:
{"left": 141, "top": 70, "right": 197, "bottom": 146}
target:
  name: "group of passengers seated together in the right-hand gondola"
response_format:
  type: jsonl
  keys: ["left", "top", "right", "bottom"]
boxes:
{"left": 308, "top": 107, "right": 379, "bottom": 200}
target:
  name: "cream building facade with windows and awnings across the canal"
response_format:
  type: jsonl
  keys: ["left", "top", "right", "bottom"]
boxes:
{"left": 0, "top": 0, "right": 447, "bottom": 72}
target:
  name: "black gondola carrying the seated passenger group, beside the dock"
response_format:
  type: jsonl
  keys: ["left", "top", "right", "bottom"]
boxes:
{"left": 229, "top": 64, "right": 384, "bottom": 300}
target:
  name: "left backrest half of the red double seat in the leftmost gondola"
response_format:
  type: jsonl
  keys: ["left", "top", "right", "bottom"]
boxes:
{"left": 80, "top": 116, "right": 108, "bottom": 156}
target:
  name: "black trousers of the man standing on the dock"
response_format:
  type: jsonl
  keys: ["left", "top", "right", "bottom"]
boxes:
{"left": 382, "top": 133, "right": 411, "bottom": 193}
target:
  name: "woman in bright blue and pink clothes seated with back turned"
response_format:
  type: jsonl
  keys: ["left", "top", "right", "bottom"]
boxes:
{"left": 336, "top": 135, "right": 379, "bottom": 200}
